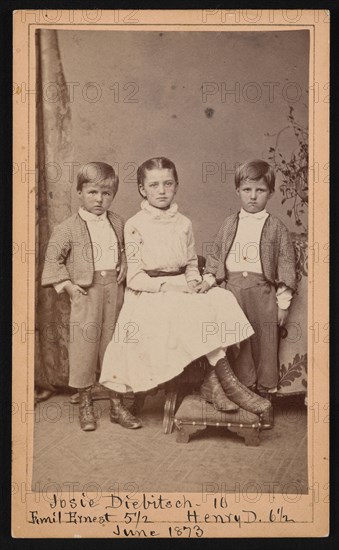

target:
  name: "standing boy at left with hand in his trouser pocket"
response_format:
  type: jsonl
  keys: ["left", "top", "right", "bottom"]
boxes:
{"left": 42, "top": 162, "right": 140, "bottom": 431}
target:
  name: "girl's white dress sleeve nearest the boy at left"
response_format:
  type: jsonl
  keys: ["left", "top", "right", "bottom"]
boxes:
{"left": 125, "top": 222, "right": 162, "bottom": 292}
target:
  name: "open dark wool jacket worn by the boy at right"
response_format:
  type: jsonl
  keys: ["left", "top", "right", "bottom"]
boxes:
{"left": 204, "top": 212, "right": 297, "bottom": 291}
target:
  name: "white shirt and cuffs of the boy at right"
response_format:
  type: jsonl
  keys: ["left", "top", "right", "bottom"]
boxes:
{"left": 204, "top": 208, "right": 292, "bottom": 309}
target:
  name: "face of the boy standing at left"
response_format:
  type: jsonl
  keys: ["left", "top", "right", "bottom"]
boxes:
{"left": 78, "top": 179, "right": 117, "bottom": 216}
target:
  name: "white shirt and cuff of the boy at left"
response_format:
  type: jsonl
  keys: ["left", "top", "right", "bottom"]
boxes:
{"left": 54, "top": 208, "right": 119, "bottom": 294}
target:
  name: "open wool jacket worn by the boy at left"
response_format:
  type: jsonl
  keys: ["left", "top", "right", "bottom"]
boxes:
{"left": 41, "top": 211, "right": 126, "bottom": 287}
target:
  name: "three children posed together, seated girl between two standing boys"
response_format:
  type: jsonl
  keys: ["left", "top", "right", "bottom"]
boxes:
{"left": 42, "top": 157, "right": 296, "bottom": 431}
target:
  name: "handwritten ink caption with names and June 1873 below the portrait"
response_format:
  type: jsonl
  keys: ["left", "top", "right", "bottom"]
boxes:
{"left": 27, "top": 493, "right": 295, "bottom": 538}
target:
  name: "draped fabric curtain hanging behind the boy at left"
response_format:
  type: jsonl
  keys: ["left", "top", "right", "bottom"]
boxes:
{"left": 35, "top": 30, "right": 73, "bottom": 395}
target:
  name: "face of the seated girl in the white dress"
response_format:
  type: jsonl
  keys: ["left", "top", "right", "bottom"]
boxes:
{"left": 140, "top": 168, "right": 177, "bottom": 210}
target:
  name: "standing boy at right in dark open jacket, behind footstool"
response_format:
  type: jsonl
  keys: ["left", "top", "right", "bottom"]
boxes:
{"left": 200, "top": 160, "right": 296, "bottom": 397}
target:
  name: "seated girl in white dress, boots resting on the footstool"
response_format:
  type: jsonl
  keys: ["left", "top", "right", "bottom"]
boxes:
{"left": 100, "top": 157, "right": 271, "bottom": 428}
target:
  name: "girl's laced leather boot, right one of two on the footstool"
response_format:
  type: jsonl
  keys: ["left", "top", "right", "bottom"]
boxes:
{"left": 215, "top": 357, "right": 273, "bottom": 430}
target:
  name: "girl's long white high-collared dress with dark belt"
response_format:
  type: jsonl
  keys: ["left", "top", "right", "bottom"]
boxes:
{"left": 100, "top": 201, "right": 254, "bottom": 393}
